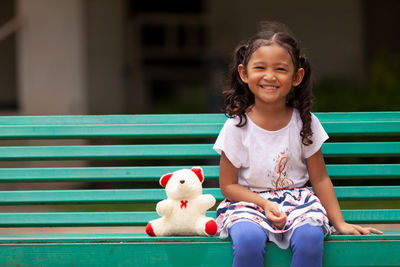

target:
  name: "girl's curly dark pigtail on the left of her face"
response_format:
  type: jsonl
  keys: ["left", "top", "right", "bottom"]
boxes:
{"left": 223, "top": 43, "right": 254, "bottom": 127}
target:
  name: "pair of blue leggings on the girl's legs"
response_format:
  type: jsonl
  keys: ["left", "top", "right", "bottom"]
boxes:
{"left": 229, "top": 221, "right": 324, "bottom": 267}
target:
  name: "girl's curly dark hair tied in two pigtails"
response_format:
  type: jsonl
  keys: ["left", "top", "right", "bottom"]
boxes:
{"left": 223, "top": 22, "right": 313, "bottom": 145}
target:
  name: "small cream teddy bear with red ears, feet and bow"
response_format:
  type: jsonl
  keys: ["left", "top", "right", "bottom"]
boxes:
{"left": 146, "top": 167, "right": 217, "bottom": 236}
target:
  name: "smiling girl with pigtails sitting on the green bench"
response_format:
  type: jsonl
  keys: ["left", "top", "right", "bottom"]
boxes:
{"left": 214, "top": 23, "right": 381, "bottom": 266}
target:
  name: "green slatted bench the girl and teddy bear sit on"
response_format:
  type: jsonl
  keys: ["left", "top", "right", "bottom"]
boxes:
{"left": 0, "top": 112, "right": 400, "bottom": 267}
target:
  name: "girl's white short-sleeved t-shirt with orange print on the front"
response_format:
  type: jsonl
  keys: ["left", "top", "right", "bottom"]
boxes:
{"left": 214, "top": 109, "right": 329, "bottom": 192}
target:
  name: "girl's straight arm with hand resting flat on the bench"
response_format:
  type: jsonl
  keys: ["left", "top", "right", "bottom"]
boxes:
{"left": 307, "top": 149, "right": 382, "bottom": 235}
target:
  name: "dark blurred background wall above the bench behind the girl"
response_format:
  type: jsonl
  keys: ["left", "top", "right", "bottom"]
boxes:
{"left": 0, "top": 0, "right": 400, "bottom": 115}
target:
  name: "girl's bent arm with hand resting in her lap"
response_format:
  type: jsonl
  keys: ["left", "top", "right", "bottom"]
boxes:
{"left": 219, "top": 153, "right": 286, "bottom": 229}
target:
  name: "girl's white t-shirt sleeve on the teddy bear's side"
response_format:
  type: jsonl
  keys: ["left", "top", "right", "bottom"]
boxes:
{"left": 213, "top": 118, "right": 246, "bottom": 168}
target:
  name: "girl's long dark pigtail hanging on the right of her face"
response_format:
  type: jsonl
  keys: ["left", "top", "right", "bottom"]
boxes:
{"left": 288, "top": 56, "right": 313, "bottom": 145}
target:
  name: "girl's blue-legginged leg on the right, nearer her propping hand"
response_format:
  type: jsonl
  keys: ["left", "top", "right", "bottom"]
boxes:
{"left": 290, "top": 224, "right": 324, "bottom": 267}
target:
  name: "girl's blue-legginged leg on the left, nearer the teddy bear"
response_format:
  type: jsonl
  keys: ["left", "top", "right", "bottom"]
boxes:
{"left": 229, "top": 221, "right": 268, "bottom": 267}
